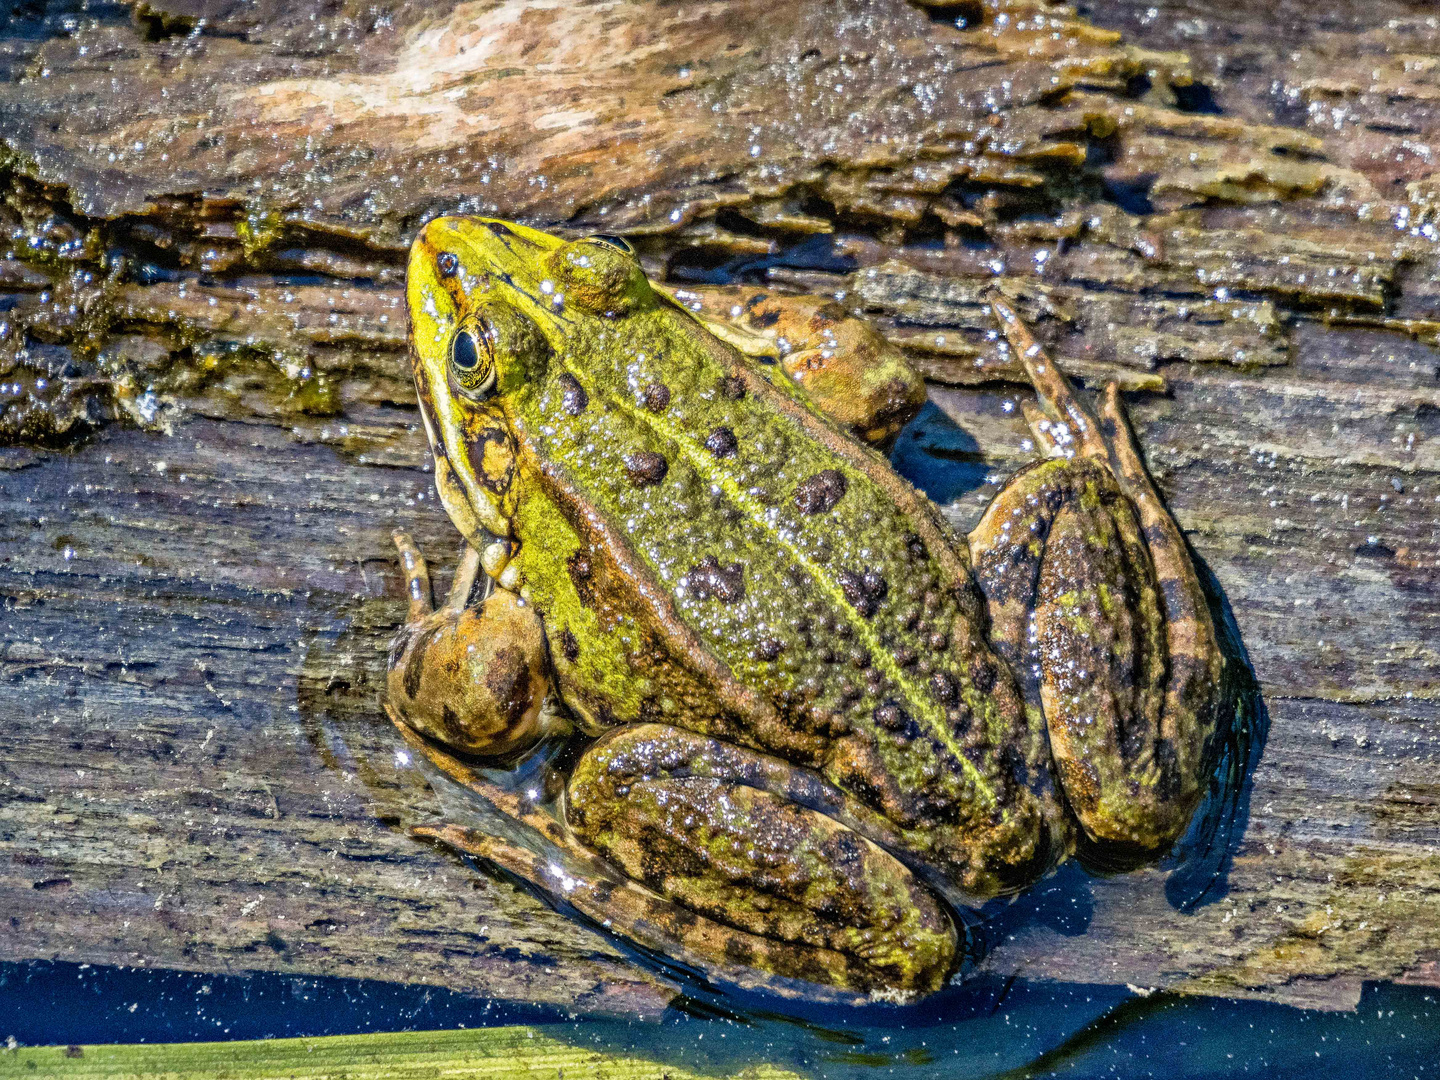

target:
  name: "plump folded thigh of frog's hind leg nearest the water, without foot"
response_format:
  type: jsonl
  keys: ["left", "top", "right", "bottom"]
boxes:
{"left": 567, "top": 724, "right": 956, "bottom": 992}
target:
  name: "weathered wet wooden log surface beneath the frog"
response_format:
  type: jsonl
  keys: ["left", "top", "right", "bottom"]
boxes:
{"left": 0, "top": 0, "right": 1440, "bottom": 1014}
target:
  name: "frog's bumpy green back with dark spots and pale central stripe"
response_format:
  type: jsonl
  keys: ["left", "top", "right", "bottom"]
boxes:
{"left": 508, "top": 307, "right": 1060, "bottom": 893}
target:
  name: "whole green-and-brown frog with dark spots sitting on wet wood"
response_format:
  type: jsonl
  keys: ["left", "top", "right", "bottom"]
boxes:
{"left": 389, "top": 217, "right": 1221, "bottom": 999}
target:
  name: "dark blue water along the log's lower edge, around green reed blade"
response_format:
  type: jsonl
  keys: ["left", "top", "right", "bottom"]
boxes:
{"left": 0, "top": 962, "right": 1440, "bottom": 1080}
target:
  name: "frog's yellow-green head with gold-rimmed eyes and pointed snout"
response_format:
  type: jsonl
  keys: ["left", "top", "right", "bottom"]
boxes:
{"left": 406, "top": 217, "right": 657, "bottom": 543}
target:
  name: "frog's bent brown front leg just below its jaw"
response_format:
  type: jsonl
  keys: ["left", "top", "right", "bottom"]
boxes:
{"left": 386, "top": 533, "right": 560, "bottom": 756}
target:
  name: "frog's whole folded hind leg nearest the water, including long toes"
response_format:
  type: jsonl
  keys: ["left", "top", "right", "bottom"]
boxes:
{"left": 420, "top": 724, "right": 958, "bottom": 998}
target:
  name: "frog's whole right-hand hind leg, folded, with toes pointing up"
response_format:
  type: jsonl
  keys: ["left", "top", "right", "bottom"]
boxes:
{"left": 969, "top": 300, "right": 1223, "bottom": 861}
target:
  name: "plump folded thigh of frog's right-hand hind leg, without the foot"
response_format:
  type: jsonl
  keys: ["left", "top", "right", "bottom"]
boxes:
{"left": 971, "top": 458, "right": 1200, "bottom": 854}
